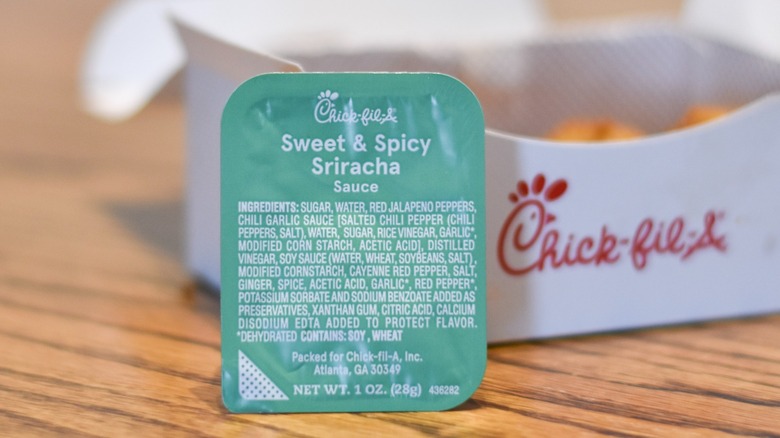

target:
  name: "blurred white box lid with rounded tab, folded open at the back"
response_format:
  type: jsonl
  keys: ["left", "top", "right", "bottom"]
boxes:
{"left": 81, "top": 0, "right": 545, "bottom": 120}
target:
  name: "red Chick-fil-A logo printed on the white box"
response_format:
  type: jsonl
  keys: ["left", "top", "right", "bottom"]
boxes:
{"left": 498, "top": 174, "right": 726, "bottom": 275}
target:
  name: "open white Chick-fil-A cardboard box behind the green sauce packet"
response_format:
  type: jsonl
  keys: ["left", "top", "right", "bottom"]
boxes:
{"left": 82, "top": 1, "right": 780, "bottom": 342}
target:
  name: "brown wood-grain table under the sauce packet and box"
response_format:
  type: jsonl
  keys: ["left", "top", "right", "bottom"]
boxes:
{"left": 0, "top": 0, "right": 780, "bottom": 437}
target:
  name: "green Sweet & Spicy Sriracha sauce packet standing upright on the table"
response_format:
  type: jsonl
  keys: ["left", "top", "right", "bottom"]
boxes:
{"left": 221, "top": 73, "right": 487, "bottom": 412}
